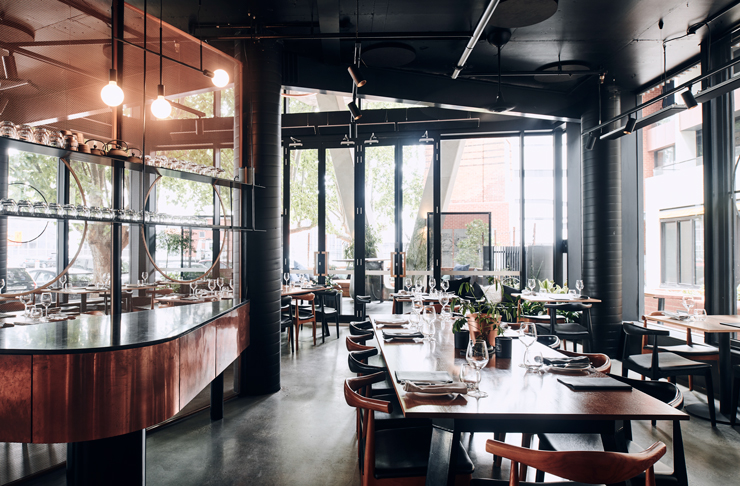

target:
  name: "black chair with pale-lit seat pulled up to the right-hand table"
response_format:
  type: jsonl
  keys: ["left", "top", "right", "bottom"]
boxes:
{"left": 622, "top": 322, "right": 717, "bottom": 427}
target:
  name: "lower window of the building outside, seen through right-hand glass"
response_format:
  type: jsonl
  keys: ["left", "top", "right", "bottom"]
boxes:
{"left": 661, "top": 218, "right": 704, "bottom": 286}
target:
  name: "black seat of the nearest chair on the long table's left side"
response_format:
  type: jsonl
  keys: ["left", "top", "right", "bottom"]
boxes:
{"left": 375, "top": 427, "right": 475, "bottom": 479}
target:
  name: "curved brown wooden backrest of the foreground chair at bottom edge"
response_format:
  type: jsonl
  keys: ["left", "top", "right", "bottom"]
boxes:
{"left": 486, "top": 440, "right": 666, "bottom": 486}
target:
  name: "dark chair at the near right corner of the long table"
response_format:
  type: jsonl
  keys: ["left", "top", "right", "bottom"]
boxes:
{"left": 537, "top": 375, "right": 688, "bottom": 486}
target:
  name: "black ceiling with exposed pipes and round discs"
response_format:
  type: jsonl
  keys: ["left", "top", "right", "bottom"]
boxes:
{"left": 131, "top": 0, "right": 740, "bottom": 116}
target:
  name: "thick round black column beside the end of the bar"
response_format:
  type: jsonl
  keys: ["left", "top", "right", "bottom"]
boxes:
{"left": 236, "top": 41, "right": 282, "bottom": 395}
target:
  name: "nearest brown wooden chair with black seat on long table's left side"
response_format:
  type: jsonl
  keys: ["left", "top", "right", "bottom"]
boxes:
{"left": 344, "top": 372, "right": 475, "bottom": 486}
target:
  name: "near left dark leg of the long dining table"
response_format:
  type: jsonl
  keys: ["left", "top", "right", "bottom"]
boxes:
{"left": 425, "top": 419, "right": 460, "bottom": 486}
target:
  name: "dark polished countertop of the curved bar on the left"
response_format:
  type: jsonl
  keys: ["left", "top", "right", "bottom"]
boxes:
{"left": 0, "top": 299, "right": 246, "bottom": 354}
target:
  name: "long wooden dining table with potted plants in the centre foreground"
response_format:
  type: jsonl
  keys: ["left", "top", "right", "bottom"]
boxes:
{"left": 371, "top": 315, "right": 689, "bottom": 485}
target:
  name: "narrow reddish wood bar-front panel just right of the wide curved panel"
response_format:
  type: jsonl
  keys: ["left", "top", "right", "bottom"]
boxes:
{"left": 178, "top": 322, "right": 216, "bottom": 408}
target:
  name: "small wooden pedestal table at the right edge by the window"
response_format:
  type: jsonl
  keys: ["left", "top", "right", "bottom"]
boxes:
{"left": 645, "top": 314, "right": 740, "bottom": 424}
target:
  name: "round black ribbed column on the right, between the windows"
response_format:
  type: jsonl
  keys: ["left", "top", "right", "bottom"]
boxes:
{"left": 581, "top": 83, "right": 622, "bottom": 357}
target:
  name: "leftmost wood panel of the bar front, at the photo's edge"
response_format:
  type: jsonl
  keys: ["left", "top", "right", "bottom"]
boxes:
{"left": 0, "top": 355, "right": 33, "bottom": 442}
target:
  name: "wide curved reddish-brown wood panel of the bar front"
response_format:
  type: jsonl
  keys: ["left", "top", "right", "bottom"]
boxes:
{"left": 31, "top": 341, "right": 179, "bottom": 443}
